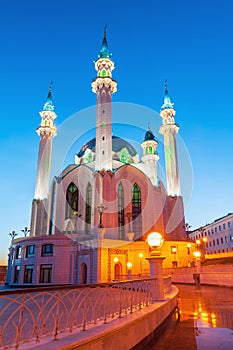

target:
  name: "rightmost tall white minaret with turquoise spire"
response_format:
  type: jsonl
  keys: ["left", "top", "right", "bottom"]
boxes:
{"left": 159, "top": 81, "right": 180, "bottom": 196}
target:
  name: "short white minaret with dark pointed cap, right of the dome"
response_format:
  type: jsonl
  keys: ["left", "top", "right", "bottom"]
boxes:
{"left": 141, "top": 127, "right": 159, "bottom": 186}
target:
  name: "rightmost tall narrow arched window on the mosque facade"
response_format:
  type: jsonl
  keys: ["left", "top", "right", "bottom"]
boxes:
{"left": 132, "top": 183, "right": 142, "bottom": 240}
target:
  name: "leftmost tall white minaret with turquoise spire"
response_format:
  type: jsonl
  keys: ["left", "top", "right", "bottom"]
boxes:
{"left": 34, "top": 83, "right": 56, "bottom": 200}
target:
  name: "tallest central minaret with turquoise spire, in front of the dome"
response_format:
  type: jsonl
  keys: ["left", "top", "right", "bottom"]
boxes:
{"left": 91, "top": 26, "right": 117, "bottom": 170}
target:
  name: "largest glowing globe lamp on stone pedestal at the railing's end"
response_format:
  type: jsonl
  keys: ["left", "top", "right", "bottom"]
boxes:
{"left": 146, "top": 232, "right": 165, "bottom": 301}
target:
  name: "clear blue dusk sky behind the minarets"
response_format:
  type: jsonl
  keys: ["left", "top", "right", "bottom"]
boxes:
{"left": 0, "top": 0, "right": 233, "bottom": 263}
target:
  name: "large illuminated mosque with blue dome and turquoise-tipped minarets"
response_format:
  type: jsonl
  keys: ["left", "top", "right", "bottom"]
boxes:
{"left": 7, "top": 31, "right": 195, "bottom": 286}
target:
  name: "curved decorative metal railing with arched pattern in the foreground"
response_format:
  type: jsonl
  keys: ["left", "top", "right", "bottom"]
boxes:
{"left": 0, "top": 278, "right": 171, "bottom": 349}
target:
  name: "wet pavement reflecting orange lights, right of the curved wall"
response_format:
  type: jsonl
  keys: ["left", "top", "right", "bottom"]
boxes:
{"left": 149, "top": 285, "right": 233, "bottom": 350}
